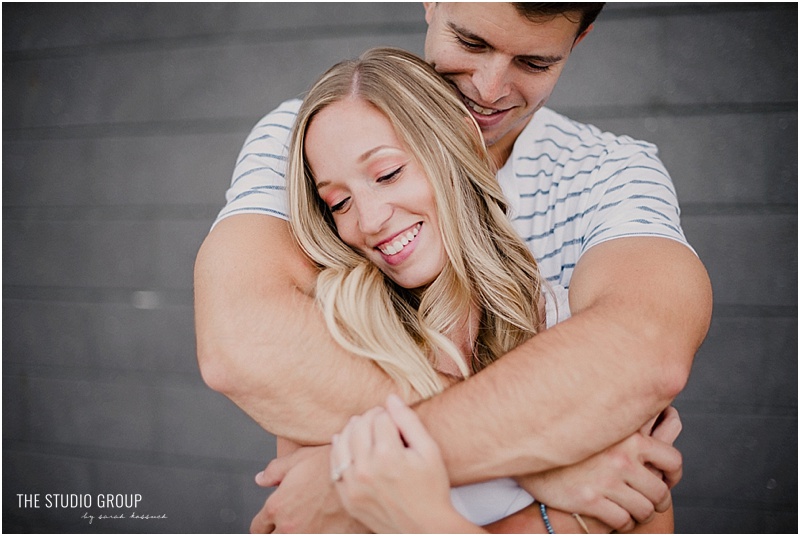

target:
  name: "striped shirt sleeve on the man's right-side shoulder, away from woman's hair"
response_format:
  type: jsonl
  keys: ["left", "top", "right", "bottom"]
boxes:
{"left": 581, "top": 139, "right": 691, "bottom": 254}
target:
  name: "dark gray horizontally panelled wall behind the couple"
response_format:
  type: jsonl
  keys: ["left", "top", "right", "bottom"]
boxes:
{"left": 3, "top": 3, "right": 797, "bottom": 533}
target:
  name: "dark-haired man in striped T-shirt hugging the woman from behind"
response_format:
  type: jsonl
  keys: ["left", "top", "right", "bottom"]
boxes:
{"left": 195, "top": 3, "right": 711, "bottom": 532}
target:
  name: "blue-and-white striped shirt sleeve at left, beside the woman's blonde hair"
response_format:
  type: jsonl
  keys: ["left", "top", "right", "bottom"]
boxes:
{"left": 214, "top": 99, "right": 301, "bottom": 225}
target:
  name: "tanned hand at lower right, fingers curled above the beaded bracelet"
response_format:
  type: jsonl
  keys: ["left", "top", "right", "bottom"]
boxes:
{"left": 517, "top": 408, "right": 683, "bottom": 531}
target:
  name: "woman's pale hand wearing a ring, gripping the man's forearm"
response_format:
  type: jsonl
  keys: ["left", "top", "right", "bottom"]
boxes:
{"left": 331, "top": 396, "right": 480, "bottom": 533}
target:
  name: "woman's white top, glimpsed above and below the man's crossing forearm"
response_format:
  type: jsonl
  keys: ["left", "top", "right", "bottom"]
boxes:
{"left": 450, "top": 285, "right": 570, "bottom": 526}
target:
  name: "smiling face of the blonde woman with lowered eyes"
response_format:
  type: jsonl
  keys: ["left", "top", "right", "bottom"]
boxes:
{"left": 305, "top": 99, "right": 447, "bottom": 289}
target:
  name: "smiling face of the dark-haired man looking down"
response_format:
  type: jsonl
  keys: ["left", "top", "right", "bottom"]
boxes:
{"left": 425, "top": 2, "right": 588, "bottom": 157}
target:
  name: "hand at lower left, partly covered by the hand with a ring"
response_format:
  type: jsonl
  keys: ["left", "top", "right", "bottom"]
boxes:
{"left": 250, "top": 445, "right": 366, "bottom": 534}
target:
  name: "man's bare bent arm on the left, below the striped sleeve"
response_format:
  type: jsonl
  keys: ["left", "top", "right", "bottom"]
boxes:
{"left": 195, "top": 214, "right": 396, "bottom": 444}
